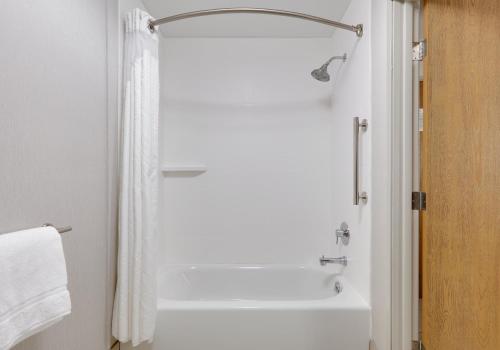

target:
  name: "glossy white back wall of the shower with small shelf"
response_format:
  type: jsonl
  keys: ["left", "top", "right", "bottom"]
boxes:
{"left": 160, "top": 38, "right": 340, "bottom": 265}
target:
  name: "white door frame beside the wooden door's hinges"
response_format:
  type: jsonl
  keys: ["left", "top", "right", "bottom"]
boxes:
{"left": 391, "top": 0, "right": 419, "bottom": 350}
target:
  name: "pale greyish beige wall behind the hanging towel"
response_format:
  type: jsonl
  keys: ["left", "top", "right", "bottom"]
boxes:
{"left": 0, "top": 0, "right": 117, "bottom": 350}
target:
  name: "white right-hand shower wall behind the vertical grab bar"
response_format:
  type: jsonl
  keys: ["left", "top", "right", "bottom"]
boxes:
{"left": 331, "top": 0, "right": 372, "bottom": 301}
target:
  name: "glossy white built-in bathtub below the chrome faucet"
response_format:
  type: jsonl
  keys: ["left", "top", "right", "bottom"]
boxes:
{"left": 122, "top": 265, "right": 370, "bottom": 350}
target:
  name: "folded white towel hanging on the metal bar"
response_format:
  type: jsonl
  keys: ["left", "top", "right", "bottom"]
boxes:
{"left": 0, "top": 227, "right": 71, "bottom": 350}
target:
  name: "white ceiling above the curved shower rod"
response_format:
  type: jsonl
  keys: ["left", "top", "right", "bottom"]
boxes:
{"left": 143, "top": 0, "right": 356, "bottom": 38}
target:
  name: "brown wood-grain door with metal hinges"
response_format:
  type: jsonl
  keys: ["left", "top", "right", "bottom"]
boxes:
{"left": 422, "top": 0, "right": 500, "bottom": 350}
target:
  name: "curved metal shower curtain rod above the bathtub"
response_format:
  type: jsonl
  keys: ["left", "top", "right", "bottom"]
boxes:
{"left": 149, "top": 7, "right": 363, "bottom": 37}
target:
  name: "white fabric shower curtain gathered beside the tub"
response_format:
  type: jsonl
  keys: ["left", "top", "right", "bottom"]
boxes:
{"left": 113, "top": 9, "right": 159, "bottom": 346}
